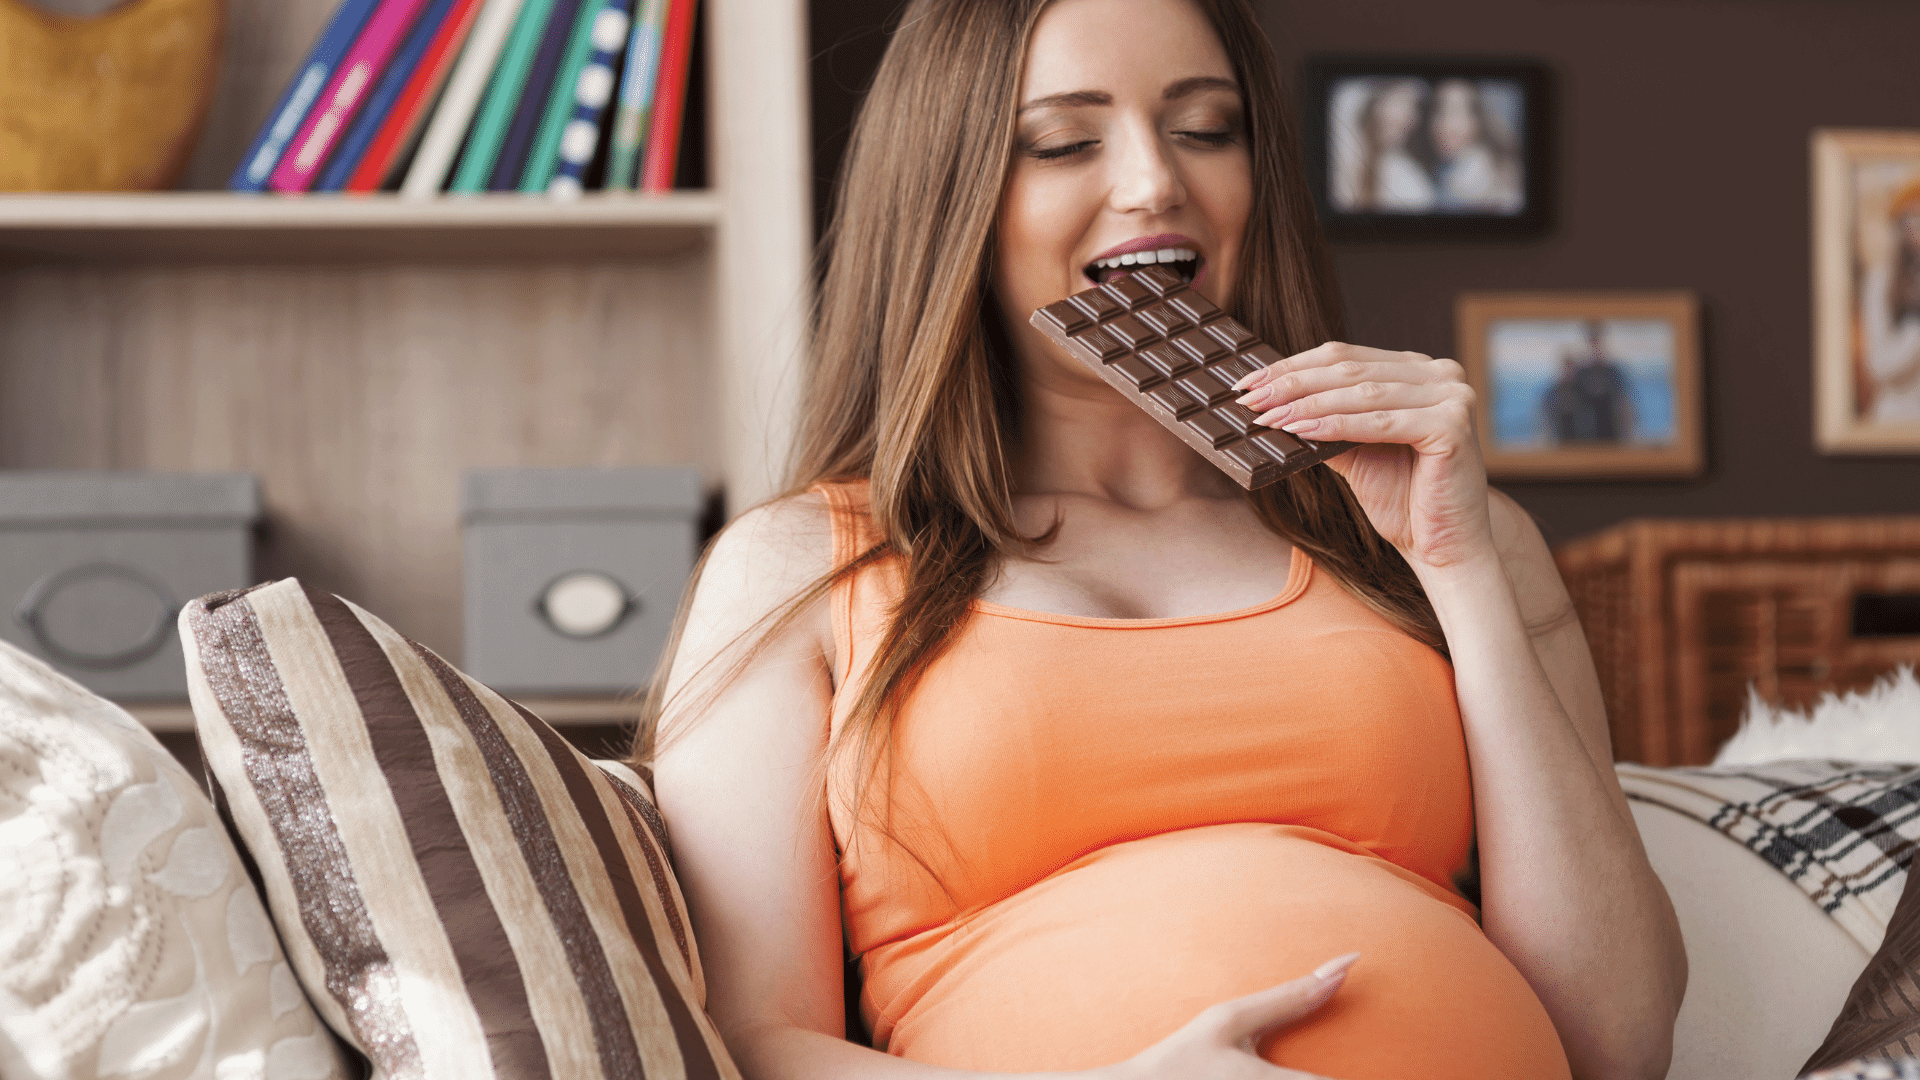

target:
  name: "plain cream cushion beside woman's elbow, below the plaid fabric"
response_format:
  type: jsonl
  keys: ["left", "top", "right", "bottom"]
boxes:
{"left": 1630, "top": 801, "right": 1868, "bottom": 1080}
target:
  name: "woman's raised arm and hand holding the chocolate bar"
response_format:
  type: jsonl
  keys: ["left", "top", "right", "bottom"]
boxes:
{"left": 1246, "top": 342, "right": 1686, "bottom": 1080}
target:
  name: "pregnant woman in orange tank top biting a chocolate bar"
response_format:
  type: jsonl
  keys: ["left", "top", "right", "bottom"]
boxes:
{"left": 637, "top": 0, "right": 1686, "bottom": 1080}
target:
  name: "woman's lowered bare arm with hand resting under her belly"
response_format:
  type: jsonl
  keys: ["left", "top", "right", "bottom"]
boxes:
{"left": 653, "top": 498, "right": 1350, "bottom": 1080}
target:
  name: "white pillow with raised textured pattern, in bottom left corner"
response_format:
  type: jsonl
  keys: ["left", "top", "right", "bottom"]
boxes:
{"left": 0, "top": 642, "right": 357, "bottom": 1080}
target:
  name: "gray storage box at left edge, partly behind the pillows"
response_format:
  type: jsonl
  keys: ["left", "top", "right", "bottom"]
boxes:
{"left": 0, "top": 471, "right": 259, "bottom": 701}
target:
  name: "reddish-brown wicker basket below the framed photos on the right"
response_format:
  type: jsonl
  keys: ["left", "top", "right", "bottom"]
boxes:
{"left": 1555, "top": 517, "right": 1920, "bottom": 765}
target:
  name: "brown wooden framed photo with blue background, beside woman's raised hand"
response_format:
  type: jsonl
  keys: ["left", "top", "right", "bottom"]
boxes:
{"left": 1455, "top": 292, "right": 1705, "bottom": 480}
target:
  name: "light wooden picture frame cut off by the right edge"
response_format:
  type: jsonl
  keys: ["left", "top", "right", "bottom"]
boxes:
{"left": 1812, "top": 131, "right": 1920, "bottom": 454}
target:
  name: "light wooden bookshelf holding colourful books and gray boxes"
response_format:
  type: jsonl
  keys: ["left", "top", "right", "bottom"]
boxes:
{"left": 0, "top": 0, "right": 812, "bottom": 707}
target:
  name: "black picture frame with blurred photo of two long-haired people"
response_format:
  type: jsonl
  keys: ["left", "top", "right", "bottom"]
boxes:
{"left": 1302, "top": 56, "right": 1553, "bottom": 240}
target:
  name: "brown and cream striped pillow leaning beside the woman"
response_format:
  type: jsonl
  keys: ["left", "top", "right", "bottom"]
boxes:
{"left": 180, "top": 578, "right": 739, "bottom": 1080}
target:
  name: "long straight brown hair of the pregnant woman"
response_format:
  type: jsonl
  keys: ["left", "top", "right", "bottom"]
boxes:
{"left": 634, "top": 0, "right": 1442, "bottom": 805}
